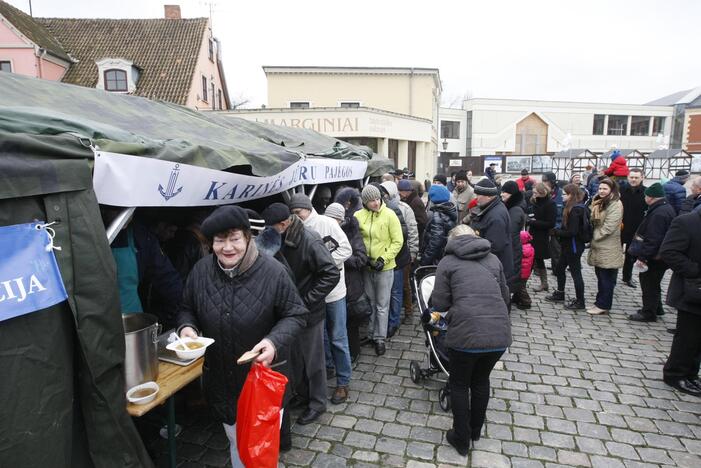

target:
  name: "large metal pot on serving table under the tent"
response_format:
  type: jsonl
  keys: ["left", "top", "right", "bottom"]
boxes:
{"left": 122, "top": 313, "right": 161, "bottom": 390}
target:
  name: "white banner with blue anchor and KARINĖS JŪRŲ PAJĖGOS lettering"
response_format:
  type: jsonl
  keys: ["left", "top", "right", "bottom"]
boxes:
{"left": 93, "top": 151, "right": 367, "bottom": 207}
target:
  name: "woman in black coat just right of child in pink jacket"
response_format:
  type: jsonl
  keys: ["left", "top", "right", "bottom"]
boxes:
{"left": 527, "top": 182, "right": 557, "bottom": 291}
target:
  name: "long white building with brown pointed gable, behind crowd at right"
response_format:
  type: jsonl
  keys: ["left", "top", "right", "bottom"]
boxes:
{"left": 439, "top": 99, "right": 673, "bottom": 172}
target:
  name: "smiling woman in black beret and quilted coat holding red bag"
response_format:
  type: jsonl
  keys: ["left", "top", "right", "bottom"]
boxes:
{"left": 178, "top": 205, "right": 308, "bottom": 466}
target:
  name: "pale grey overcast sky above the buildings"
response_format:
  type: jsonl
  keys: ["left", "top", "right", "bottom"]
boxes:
{"left": 9, "top": 0, "right": 701, "bottom": 107}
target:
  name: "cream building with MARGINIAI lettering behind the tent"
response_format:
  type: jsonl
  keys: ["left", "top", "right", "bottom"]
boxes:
{"left": 216, "top": 67, "right": 442, "bottom": 180}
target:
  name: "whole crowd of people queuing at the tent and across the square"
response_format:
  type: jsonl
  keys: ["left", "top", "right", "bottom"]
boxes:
{"left": 105, "top": 159, "right": 701, "bottom": 466}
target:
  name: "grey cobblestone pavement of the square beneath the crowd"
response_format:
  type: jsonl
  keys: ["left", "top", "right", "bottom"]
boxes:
{"left": 144, "top": 267, "right": 701, "bottom": 468}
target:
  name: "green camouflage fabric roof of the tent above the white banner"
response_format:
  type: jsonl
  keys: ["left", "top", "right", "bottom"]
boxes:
{"left": 0, "top": 73, "right": 393, "bottom": 176}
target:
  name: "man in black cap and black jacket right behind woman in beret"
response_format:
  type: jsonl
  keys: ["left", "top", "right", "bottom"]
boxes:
{"left": 262, "top": 203, "right": 341, "bottom": 425}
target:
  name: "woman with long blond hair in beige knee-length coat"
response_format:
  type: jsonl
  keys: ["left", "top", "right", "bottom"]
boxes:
{"left": 587, "top": 178, "right": 624, "bottom": 315}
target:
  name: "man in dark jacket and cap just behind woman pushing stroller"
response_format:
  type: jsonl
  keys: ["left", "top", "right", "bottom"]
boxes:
{"left": 470, "top": 179, "right": 514, "bottom": 278}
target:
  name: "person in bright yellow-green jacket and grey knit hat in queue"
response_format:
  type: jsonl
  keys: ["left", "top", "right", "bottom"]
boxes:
{"left": 354, "top": 185, "right": 404, "bottom": 356}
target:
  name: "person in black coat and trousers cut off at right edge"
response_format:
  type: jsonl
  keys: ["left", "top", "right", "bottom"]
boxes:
{"left": 659, "top": 210, "right": 701, "bottom": 396}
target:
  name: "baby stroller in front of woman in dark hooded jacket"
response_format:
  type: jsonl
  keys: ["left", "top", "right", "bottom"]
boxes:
{"left": 409, "top": 266, "right": 450, "bottom": 411}
